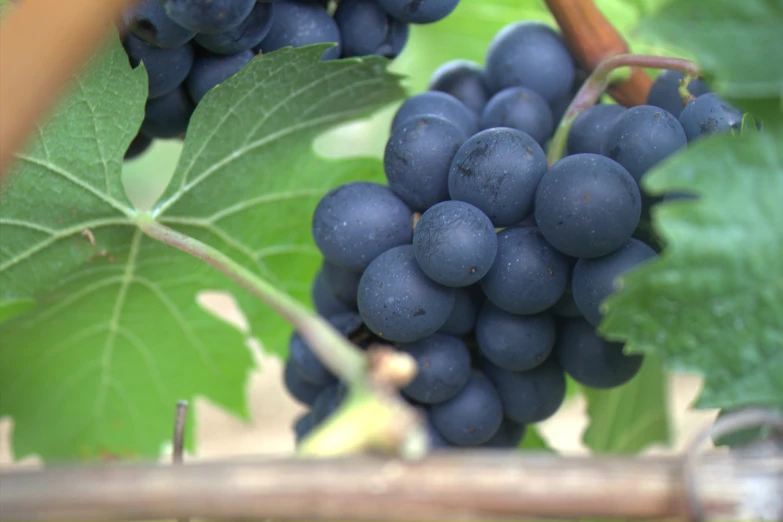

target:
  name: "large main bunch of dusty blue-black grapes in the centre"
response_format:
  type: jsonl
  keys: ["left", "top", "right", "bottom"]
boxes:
{"left": 285, "top": 18, "right": 742, "bottom": 448}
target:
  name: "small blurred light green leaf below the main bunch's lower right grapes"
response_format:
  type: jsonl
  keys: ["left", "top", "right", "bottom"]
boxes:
{"left": 582, "top": 356, "right": 669, "bottom": 453}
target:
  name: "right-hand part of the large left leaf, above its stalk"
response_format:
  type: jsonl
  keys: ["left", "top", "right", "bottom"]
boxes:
{"left": 153, "top": 45, "right": 404, "bottom": 354}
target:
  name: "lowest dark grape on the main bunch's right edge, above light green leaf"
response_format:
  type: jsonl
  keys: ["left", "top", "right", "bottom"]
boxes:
{"left": 555, "top": 318, "right": 643, "bottom": 389}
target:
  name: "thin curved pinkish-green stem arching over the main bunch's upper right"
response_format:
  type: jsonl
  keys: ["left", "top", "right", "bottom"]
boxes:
{"left": 547, "top": 54, "right": 701, "bottom": 165}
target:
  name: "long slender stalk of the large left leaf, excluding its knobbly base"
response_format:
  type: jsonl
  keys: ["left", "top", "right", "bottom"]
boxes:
{"left": 137, "top": 214, "right": 367, "bottom": 384}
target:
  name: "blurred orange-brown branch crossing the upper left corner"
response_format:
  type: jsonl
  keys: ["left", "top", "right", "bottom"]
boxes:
{"left": 0, "top": 0, "right": 135, "bottom": 182}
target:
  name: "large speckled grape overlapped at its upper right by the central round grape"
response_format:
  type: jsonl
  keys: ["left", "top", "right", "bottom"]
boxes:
{"left": 358, "top": 245, "right": 454, "bottom": 343}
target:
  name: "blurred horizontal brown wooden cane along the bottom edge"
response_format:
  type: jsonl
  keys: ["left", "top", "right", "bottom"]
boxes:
{"left": 0, "top": 450, "right": 783, "bottom": 521}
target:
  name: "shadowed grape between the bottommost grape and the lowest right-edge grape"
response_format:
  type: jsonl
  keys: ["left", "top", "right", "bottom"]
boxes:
{"left": 483, "top": 357, "right": 565, "bottom": 424}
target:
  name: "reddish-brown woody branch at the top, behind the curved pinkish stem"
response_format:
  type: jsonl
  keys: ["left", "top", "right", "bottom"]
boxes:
{"left": 546, "top": 0, "right": 652, "bottom": 107}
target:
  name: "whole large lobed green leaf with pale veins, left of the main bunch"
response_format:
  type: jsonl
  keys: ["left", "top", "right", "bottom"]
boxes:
{"left": 0, "top": 38, "right": 402, "bottom": 460}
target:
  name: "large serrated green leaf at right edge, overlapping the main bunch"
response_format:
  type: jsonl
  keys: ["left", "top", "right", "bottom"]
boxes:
{"left": 601, "top": 132, "right": 783, "bottom": 408}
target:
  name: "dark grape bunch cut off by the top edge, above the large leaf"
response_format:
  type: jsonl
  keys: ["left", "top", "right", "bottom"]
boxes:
{"left": 122, "top": 0, "right": 466, "bottom": 159}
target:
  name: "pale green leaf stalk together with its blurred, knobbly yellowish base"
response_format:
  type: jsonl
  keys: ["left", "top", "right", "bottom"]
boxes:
{"left": 137, "top": 214, "right": 426, "bottom": 458}
